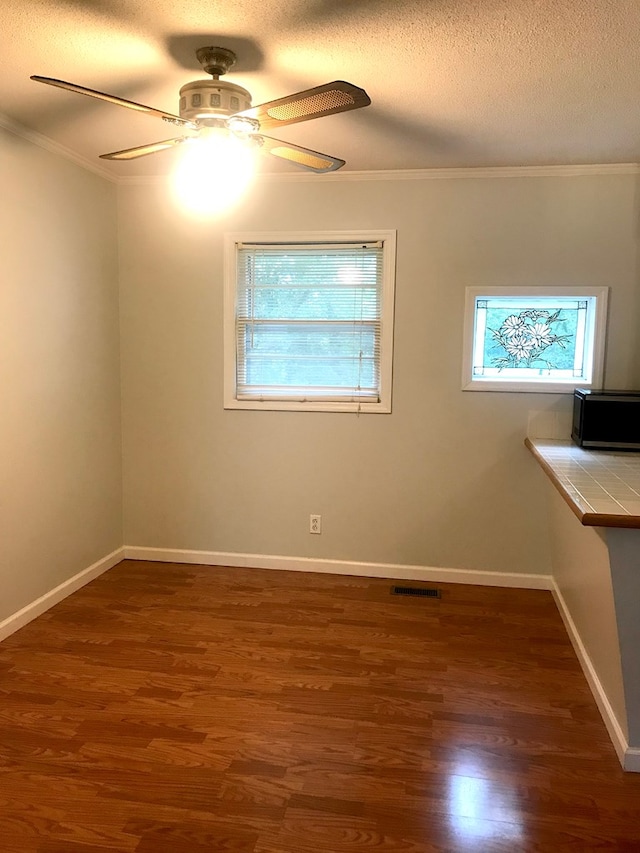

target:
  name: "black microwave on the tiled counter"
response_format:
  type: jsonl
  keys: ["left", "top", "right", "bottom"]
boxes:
{"left": 571, "top": 388, "right": 640, "bottom": 450}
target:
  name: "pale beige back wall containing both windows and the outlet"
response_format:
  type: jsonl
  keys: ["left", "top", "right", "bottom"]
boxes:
{"left": 119, "top": 174, "right": 640, "bottom": 573}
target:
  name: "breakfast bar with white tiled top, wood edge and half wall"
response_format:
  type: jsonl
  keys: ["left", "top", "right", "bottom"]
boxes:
{"left": 526, "top": 439, "right": 640, "bottom": 772}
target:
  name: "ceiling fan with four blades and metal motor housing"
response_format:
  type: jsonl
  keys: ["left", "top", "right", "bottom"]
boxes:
{"left": 31, "top": 47, "right": 371, "bottom": 173}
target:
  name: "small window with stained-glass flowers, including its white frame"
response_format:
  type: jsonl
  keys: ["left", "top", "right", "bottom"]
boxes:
{"left": 462, "top": 287, "right": 608, "bottom": 392}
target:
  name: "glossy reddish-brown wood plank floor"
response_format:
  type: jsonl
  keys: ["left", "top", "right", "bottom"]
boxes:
{"left": 0, "top": 561, "right": 640, "bottom": 853}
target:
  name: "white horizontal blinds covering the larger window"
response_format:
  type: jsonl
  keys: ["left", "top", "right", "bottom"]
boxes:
{"left": 235, "top": 242, "right": 383, "bottom": 402}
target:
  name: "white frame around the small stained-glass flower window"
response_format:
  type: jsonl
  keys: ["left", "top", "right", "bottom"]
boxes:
{"left": 462, "top": 286, "right": 609, "bottom": 394}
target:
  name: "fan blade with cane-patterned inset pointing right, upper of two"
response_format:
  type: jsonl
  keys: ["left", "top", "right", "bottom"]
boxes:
{"left": 237, "top": 80, "right": 371, "bottom": 130}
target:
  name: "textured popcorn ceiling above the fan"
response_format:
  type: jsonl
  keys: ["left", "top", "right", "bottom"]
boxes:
{"left": 0, "top": 0, "right": 640, "bottom": 176}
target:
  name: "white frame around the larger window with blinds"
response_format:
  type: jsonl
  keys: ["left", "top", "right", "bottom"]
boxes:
{"left": 224, "top": 230, "right": 396, "bottom": 414}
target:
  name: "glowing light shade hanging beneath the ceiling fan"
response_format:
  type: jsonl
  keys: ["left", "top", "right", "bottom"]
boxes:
{"left": 172, "top": 128, "right": 256, "bottom": 216}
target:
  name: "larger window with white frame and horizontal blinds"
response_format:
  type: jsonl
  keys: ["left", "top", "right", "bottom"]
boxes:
{"left": 224, "top": 231, "right": 395, "bottom": 412}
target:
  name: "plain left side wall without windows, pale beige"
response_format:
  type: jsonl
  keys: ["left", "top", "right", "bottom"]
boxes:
{"left": 0, "top": 129, "right": 122, "bottom": 620}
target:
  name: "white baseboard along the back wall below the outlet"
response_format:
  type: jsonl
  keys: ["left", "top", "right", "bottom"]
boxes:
{"left": 123, "top": 545, "right": 553, "bottom": 590}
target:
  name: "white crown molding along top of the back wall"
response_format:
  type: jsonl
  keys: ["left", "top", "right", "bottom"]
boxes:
{"left": 115, "top": 163, "right": 640, "bottom": 186}
